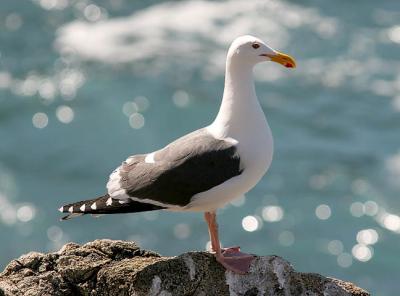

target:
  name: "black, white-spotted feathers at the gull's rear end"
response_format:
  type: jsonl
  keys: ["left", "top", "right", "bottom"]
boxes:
{"left": 59, "top": 194, "right": 164, "bottom": 220}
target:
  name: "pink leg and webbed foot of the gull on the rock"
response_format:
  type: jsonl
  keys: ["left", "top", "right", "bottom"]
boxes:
{"left": 204, "top": 212, "right": 254, "bottom": 274}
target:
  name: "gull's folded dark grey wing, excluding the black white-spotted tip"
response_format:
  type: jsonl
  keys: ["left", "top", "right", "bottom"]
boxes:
{"left": 107, "top": 129, "right": 242, "bottom": 206}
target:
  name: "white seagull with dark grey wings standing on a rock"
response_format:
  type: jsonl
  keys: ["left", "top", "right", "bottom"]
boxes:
{"left": 59, "top": 35, "right": 296, "bottom": 274}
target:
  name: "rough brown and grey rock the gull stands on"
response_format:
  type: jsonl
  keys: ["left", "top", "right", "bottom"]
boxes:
{"left": 0, "top": 240, "right": 369, "bottom": 296}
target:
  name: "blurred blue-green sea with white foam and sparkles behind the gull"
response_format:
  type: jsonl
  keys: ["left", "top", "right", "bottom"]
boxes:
{"left": 0, "top": 0, "right": 400, "bottom": 295}
